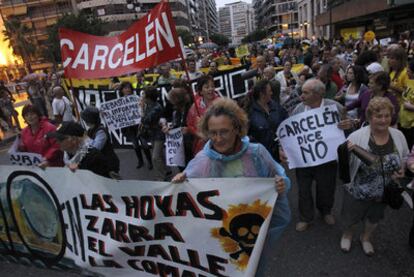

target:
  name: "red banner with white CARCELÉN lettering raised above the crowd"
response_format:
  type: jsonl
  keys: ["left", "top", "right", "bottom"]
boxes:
{"left": 59, "top": 1, "right": 181, "bottom": 79}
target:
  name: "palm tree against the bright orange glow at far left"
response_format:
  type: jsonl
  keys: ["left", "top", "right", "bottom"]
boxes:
{"left": 3, "top": 18, "right": 36, "bottom": 72}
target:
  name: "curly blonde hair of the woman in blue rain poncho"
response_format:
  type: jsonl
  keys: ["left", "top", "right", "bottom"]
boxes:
{"left": 198, "top": 98, "right": 248, "bottom": 138}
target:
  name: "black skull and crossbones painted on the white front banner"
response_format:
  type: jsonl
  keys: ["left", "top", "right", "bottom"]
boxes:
{"left": 220, "top": 213, "right": 264, "bottom": 260}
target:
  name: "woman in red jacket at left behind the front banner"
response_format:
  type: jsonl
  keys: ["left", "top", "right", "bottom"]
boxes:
{"left": 18, "top": 104, "right": 63, "bottom": 168}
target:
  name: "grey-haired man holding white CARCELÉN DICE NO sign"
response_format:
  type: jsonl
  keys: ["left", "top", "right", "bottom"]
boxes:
{"left": 277, "top": 79, "right": 352, "bottom": 232}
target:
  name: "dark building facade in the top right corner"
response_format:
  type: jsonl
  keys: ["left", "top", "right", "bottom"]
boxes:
{"left": 315, "top": 0, "right": 414, "bottom": 39}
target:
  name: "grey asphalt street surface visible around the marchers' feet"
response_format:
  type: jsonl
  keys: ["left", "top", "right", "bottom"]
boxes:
{"left": 0, "top": 148, "right": 414, "bottom": 277}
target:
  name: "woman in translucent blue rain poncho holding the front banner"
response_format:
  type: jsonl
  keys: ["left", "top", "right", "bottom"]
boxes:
{"left": 172, "top": 98, "right": 290, "bottom": 276}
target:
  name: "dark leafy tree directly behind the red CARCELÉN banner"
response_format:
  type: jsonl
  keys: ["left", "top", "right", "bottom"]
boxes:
{"left": 43, "top": 11, "right": 105, "bottom": 64}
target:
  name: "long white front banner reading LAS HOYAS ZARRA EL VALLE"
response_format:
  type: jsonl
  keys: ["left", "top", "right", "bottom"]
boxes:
{"left": 0, "top": 166, "right": 277, "bottom": 277}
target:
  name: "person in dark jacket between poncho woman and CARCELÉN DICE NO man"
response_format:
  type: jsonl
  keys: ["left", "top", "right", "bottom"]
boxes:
{"left": 245, "top": 80, "right": 288, "bottom": 159}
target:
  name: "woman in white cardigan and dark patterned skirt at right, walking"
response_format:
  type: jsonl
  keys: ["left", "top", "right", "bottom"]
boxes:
{"left": 341, "top": 97, "right": 408, "bottom": 256}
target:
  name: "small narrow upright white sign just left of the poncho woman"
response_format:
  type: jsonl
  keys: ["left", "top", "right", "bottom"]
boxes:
{"left": 165, "top": 128, "right": 185, "bottom": 166}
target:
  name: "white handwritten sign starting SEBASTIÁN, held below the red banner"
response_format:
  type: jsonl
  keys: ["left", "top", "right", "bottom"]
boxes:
{"left": 100, "top": 95, "right": 141, "bottom": 130}
